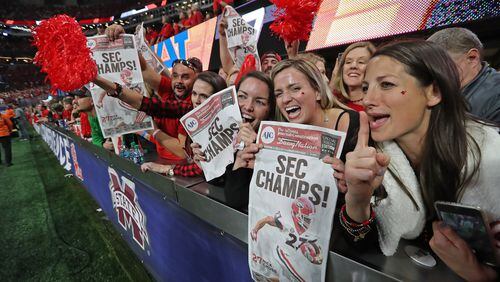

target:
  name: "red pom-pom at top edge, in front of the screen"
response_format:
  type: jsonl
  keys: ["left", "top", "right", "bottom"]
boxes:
{"left": 269, "top": 0, "right": 321, "bottom": 42}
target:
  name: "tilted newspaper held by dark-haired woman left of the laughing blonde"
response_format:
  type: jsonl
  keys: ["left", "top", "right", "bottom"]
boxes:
{"left": 181, "top": 86, "right": 242, "bottom": 181}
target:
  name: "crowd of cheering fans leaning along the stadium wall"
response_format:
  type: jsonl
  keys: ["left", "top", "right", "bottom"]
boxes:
{"left": 0, "top": 2, "right": 500, "bottom": 281}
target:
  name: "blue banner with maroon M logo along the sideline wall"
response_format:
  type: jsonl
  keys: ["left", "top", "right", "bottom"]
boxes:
{"left": 35, "top": 125, "right": 251, "bottom": 282}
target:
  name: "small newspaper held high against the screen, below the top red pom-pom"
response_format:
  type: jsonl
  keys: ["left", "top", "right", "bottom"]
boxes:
{"left": 224, "top": 6, "right": 260, "bottom": 71}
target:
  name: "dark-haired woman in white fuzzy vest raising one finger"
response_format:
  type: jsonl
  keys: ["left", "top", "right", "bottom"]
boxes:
{"left": 339, "top": 41, "right": 500, "bottom": 281}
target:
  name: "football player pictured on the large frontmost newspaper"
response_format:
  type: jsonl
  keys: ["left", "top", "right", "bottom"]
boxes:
{"left": 250, "top": 197, "right": 323, "bottom": 281}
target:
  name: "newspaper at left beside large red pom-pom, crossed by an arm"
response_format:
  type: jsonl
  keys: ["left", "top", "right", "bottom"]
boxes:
{"left": 87, "top": 34, "right": 153, "bottom": 138}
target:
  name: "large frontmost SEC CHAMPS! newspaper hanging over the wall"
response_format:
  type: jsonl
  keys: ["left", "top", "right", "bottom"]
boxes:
{"left": 248, "top": 121, "right": 345, "bottom": 281}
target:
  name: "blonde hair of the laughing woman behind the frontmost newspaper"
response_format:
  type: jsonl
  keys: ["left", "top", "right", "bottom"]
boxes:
{"left": 271, "top": 59, "right": 343, "bottom": 121}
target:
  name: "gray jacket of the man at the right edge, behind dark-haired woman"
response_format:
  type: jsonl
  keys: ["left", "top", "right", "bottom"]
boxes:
{"left": 462, "top": 62, "right": 500, "bottom": 124}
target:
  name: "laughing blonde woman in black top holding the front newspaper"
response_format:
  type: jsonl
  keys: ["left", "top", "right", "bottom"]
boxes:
{"left": 235, "top": 60, "right": 359, "bottom": 192}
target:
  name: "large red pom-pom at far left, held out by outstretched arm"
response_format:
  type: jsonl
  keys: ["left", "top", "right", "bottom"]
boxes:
{"left": 33, "top": 15, "right": 97, "bottom": 92}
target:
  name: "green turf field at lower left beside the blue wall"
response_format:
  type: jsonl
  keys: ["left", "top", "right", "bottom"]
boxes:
{"left": 0, "top": 136, "right": 152, "bottom": 281}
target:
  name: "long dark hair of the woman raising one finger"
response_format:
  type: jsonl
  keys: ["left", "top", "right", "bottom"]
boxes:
{"left": 372, "top": 40, "right": 481, "bottom": 217}
